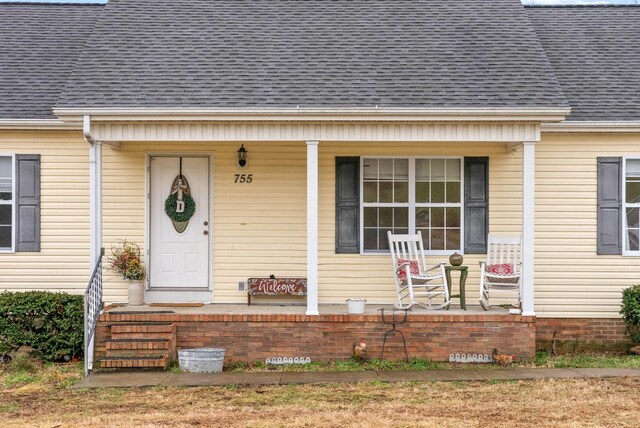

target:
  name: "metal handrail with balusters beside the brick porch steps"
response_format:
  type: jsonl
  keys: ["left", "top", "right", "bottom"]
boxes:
{"left": 84, "top": 248, "right": 104, "bottom": 376}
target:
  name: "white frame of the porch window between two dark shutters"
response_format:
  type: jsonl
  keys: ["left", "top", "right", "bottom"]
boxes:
{"left": 359, "top": 155, "right": 464, "bottom": 256}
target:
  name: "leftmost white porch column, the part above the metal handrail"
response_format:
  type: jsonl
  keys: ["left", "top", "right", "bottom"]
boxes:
{"left": 89, "top": 141, "right": 102, "bottom": 268}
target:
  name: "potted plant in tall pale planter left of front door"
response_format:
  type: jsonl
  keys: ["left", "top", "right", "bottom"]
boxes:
{"left": 109, "top": 240, "right": 147, "bottom": 306}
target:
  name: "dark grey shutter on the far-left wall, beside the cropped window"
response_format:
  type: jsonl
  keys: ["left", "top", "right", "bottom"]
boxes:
{"left": 15, "top": 155, "right": 40, "bottom": 251}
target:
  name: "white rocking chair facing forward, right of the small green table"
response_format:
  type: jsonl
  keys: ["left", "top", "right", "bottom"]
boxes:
{"left": 479, "top": 234, "right": 522, "bottom": 311}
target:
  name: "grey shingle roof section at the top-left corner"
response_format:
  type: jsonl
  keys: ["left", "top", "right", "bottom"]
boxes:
{"left": 0, "top": 3, "right": 102, "bottom": 119}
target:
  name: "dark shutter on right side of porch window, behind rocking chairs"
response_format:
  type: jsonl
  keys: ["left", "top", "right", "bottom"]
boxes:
{"left": 464, "top": 157, "right": 489, "bottom": 254}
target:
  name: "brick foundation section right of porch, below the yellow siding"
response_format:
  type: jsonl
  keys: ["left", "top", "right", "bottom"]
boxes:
{"left": 536, "top": 318, "right": 631, "bottom": 354}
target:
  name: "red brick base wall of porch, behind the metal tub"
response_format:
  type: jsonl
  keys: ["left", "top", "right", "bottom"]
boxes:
{"left": 96, "top": 312, "right": 536, "bottom": 362}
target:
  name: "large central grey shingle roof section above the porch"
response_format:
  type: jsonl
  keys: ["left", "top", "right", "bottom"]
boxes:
{"left": 57, "top": 0, "right": 568, "bottom": 112}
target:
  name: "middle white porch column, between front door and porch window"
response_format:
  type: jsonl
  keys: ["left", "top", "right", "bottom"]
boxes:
{"left": 307, "top": 141, "right": 320, "bottom": 315}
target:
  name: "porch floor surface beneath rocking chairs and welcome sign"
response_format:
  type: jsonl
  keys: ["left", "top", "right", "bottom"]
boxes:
{"left": 107, "top": 303, "right": 509, "bottom": 315}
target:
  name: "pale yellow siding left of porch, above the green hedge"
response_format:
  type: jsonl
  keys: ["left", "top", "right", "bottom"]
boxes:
{"left": 0, "top": 131, "right": 90, "bottom": 293}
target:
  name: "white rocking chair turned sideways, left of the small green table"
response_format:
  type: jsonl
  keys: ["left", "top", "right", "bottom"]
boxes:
{"left": 387, "top": 232, "right": 451, "bottom": 309}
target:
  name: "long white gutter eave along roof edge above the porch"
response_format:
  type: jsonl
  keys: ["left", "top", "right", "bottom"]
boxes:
{"left": 53, "top": 107, "right": 571, "bottom": 122}
